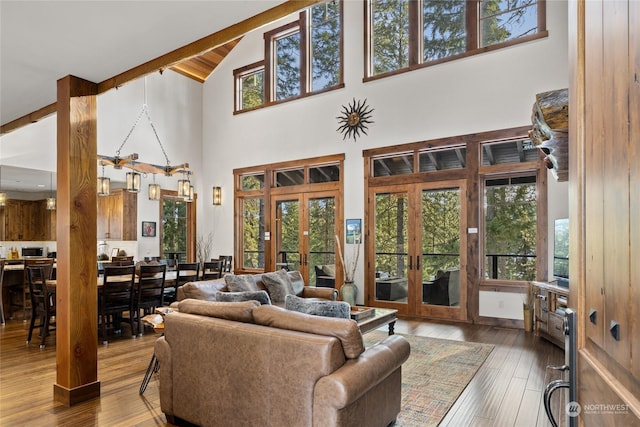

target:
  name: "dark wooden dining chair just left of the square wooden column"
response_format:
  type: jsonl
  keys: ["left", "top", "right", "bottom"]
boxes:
{"left": 26, "top": 265, "right": 56, "bottom": 348}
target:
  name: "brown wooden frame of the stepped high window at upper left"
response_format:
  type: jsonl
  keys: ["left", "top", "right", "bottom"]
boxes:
{"left": 233, "top": 0, "right": 344, "bottom": 114}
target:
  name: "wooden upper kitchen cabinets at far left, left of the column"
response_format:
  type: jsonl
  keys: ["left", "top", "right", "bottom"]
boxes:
{"left": 0, "top": 199, "right": 56, "bottom": 241}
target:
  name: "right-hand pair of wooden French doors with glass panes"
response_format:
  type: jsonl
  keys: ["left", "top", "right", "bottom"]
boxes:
{"left": 367, "top": 180, "right": 467, "bottom": 320}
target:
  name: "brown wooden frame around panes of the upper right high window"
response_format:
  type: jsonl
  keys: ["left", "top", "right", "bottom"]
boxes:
{"left": 362, "top": 0, "right": 549, "bottom": 82}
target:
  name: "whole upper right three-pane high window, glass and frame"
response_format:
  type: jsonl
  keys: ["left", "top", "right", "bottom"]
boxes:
{"left": 365, "top": 0, "right": 547, "bottom": 79}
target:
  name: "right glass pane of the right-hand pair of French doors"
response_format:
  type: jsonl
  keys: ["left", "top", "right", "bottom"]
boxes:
{"left": 421, "top": 188, "right": 460, "bottom": 306}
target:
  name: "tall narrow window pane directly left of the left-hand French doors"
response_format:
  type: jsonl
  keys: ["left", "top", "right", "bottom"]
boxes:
{"left": 242, "top": 198, "right": 264, "bottom": 268}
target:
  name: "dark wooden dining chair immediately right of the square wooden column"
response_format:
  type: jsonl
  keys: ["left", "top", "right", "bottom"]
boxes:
{"left": 98, "top": 265, "right": 136, "bottom": 344}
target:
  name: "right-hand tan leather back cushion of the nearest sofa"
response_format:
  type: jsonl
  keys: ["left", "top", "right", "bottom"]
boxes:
{"left": 253, "top": 305, "right": 364, "bottom": 359}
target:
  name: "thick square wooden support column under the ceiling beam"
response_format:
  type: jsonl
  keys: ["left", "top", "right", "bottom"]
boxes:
{"left": 53, "top": 76, "right": 100, "bottom": 406}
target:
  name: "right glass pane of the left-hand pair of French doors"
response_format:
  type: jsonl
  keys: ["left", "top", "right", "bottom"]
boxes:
{"left": 307, "top": 197, "right": 336, "bottom": 287}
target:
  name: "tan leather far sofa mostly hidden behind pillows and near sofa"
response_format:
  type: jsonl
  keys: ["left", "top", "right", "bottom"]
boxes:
{"left": 176, "top": 271, "right": 338, "bottom": 306}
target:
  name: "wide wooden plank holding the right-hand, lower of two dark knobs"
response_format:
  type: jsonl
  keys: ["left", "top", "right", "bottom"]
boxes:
{"left": 602, "top": 1, "right": 630, "bottom": 369}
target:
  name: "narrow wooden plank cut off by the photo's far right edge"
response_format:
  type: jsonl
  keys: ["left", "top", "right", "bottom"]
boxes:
{"left": 628, "top": 1, "right": 640, "bottom": 379}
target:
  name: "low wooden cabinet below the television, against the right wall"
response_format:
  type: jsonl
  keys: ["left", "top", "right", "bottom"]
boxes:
{"left": 534, "top": 282, "right": 569, "bottom": 348}
